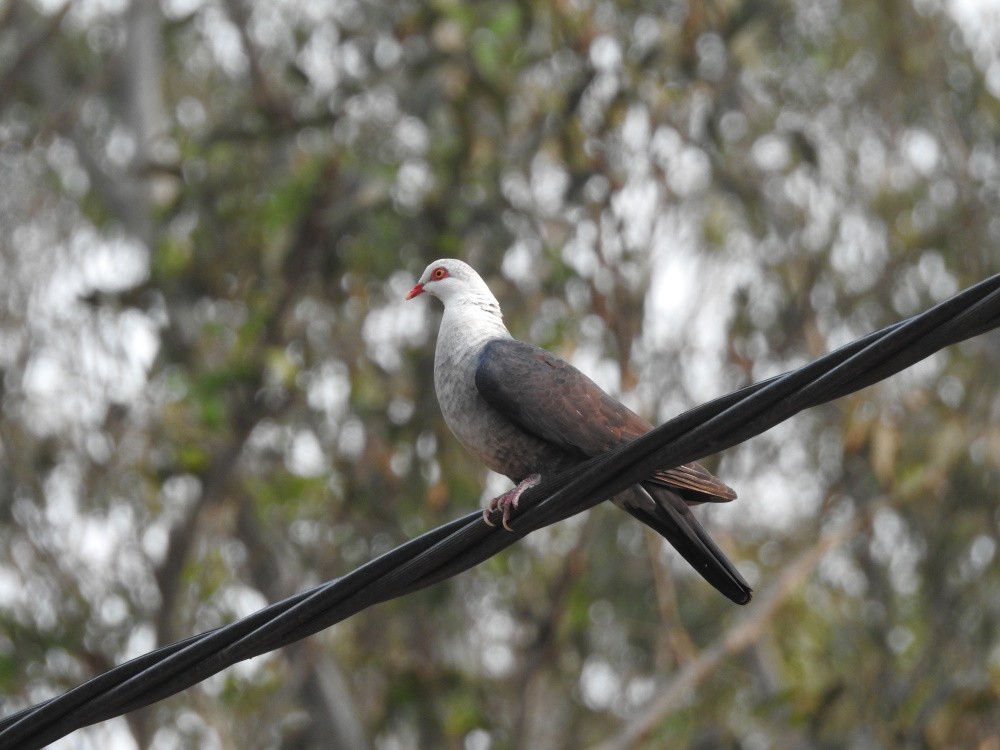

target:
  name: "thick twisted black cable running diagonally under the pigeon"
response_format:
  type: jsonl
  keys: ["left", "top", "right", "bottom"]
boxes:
{"left": 0, "top": 275, "right": 1000, "bottom": 750}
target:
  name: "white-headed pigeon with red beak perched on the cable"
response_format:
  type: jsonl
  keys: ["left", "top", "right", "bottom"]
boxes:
{"left": 406, "top": 258, "right": 752, "bottom": 604}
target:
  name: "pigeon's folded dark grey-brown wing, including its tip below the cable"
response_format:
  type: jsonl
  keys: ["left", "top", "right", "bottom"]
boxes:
{"left": 476, "top": 339, "right": 736, "bottom": 504}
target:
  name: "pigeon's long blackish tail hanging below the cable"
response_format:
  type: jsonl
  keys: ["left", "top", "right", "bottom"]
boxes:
{"left": 613, "top": 483, "right": 753, "bottom": 604}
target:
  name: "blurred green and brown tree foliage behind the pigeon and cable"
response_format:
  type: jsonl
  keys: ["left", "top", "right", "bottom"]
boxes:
{"left": 0, "top": 0, "right": 1000, "bottom": 750}
